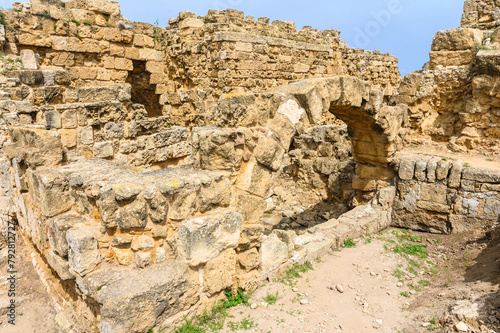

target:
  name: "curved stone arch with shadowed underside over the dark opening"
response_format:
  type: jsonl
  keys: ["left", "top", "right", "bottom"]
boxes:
{"left": 274, "top": 76, "right": 407, "bottom": 192}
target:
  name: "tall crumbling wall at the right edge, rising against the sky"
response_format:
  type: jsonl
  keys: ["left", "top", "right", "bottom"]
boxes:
{"left": 396, "top": 0, "right": 500, "bottom": 153}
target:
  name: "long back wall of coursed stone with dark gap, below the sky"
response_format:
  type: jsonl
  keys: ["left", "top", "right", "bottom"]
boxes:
{"left": 0, "top": 0, "right": 400, "bottom": 127}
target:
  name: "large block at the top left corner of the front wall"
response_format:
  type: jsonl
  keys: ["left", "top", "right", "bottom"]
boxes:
{"left": 28, "top": 168, "right": 74, "bottom": 217}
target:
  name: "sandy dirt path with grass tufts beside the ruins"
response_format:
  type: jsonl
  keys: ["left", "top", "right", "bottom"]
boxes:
{"left": 224, "top": 229, "right": 500, "bottom": 333}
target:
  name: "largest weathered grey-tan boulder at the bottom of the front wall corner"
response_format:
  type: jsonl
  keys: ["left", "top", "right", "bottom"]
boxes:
{"left": 78, "top": 260, "right": 200, "bottom": 333}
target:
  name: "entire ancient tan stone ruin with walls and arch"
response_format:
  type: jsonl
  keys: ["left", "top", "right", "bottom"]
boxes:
{"left": 0, "top": 0, "right": 500, "bottom": 333}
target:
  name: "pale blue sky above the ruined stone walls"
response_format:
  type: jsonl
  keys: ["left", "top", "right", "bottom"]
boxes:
{"left": 0, "top": 0, "right": 464, "bottom": 75}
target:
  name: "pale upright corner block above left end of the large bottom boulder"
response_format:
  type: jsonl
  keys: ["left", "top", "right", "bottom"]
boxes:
{"left": 66, "top": 227, "right": 101, "bottom": 276}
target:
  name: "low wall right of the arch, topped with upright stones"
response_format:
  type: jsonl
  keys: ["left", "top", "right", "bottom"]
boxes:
{"left": 392, "top": 154, "right": 500, "bottom": 233}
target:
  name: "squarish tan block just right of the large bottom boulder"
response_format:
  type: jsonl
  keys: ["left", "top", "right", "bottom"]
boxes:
{"left": 203, "top": 249, "right": 236, "bottom": 295}
